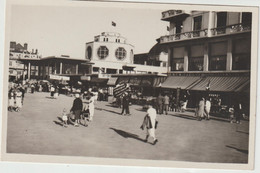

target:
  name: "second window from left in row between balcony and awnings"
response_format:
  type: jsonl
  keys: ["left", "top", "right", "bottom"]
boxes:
{"left": 189, "top": 45, "right": 204, "bottom": 71}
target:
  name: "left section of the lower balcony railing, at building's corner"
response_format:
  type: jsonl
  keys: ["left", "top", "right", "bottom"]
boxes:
{"left": 160, "top": 29, "right": 208, "bottom": 43}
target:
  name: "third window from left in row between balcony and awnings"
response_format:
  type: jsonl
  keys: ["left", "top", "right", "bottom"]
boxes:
{"left": 209, "top": 42, "right": 227, "bottom": 71}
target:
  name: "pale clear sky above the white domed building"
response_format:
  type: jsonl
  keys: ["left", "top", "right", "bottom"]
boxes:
{"left": 10, "top": 5, "right": 169, "bottom": 58}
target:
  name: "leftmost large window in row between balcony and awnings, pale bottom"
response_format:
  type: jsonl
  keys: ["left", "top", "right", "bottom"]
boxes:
{"left": 171, "top": 47, "right": 185, "bottom": 71}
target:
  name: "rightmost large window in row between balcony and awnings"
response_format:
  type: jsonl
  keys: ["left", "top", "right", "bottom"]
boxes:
{"left": 232, "top": 39, "right": 251, "bottom": 70}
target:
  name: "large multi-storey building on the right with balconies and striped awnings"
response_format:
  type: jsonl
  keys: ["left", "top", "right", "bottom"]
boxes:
{"left": 159, "top": 10, "right": 252, "bottom": 111}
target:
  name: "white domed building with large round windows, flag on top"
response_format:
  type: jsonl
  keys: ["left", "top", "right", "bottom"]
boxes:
{"left": 85, "top": 32, "right": 167, "bottom": 74}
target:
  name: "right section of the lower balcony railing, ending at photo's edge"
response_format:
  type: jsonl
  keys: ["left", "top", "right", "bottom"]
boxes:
{"left": 211, "top": 23, "right": 251, "bottom": 36}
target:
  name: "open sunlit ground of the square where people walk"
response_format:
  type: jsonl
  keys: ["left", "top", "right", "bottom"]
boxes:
{"left": 7, "top": 93, "right": 249, "bottom": 163}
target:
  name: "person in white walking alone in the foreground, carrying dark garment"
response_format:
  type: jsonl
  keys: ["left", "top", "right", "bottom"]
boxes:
{"left": 140, "top": 105, "right": 158, "bottom": 145}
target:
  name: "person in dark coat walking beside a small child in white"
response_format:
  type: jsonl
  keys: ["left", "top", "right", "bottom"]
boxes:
{"left": 70, "top": 94, "right": 83, "bottom": 127}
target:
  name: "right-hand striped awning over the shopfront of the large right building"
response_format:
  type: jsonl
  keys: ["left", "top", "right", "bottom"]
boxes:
{"left": 190, "top": 76, "right": 250, "bottom": 92}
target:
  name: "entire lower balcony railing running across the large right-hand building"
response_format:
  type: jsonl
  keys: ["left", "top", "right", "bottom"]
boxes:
{"left": 160, "top": 23, "right": 251, "bottom": 43}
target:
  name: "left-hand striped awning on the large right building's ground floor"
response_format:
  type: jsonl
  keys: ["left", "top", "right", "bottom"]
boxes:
{"left": 161, "top": 76, "right": 201, "bottom": 89}
